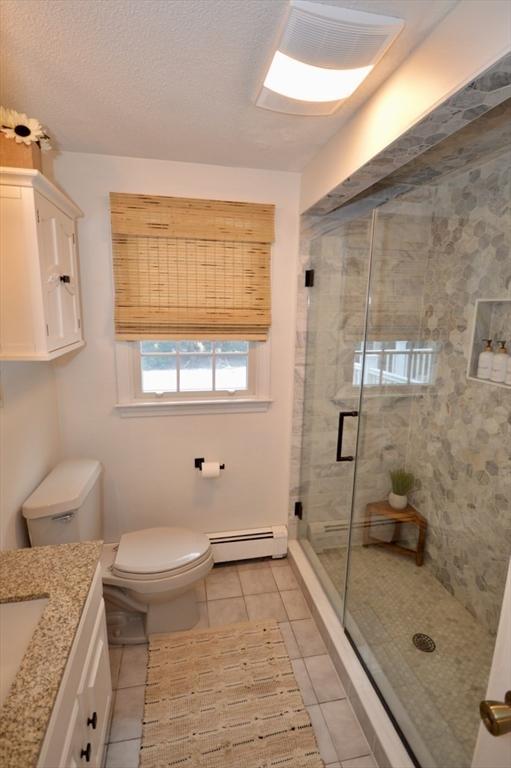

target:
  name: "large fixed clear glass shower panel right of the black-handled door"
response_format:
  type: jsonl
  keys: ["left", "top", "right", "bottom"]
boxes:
{"left": 343, "top": 146, "right": 511, "bottom": 768}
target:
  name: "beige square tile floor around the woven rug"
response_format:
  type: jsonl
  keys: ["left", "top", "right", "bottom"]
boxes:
{"left": 106, "top": 560, "right": 376, "bottom": 768}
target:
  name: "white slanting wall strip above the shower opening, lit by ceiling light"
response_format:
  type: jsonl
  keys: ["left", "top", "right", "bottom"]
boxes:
{"left": 300, "top": 0, "right": 511, "bottom": 211}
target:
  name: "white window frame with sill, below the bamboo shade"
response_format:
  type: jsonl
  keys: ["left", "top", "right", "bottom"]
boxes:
{"left": 115, "top": 339, "right": 272, "bottom": 416}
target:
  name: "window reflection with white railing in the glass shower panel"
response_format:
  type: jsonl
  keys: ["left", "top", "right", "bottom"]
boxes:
{"left": 353, "top": 341, "right": 438, "bottom": 387}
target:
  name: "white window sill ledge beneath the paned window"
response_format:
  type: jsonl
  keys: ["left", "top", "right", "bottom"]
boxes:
{"left": 115, "top": 398, "right": 273, "bottom": 418}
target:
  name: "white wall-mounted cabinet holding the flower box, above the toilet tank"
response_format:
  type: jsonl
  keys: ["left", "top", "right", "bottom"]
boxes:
{"left": 0, "top": 168, "right": 84, "bottom": 360}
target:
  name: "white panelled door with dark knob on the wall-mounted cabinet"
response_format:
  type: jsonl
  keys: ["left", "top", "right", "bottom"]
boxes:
{"left": 36, "top": 195, "right": 82, "bottom": 352}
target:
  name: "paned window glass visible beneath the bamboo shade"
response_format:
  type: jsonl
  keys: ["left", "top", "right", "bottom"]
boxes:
{"left": 137, "top": 341, "right": 252, "bottom": 396}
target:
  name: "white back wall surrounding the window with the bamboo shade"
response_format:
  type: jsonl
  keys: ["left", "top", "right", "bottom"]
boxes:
{"left": 54, "top": 153, "right": 299, "bottom": 540}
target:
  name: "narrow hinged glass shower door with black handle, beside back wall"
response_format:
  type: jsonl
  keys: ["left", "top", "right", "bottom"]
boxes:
{"left": 299, "top": 216, "right": 372, "bottom": 616}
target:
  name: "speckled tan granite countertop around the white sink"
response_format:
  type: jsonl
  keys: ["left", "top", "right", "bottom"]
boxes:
{"left": 0, "top": 541, "right": 102, "bottom": 768}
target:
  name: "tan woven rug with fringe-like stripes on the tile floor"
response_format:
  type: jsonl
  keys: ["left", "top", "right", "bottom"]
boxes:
{"left": 140, "top": 621, "right": 324, "bottom": 768}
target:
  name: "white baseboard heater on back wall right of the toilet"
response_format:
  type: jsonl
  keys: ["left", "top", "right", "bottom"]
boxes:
{"left": 207, "top": 525, "right": 287, "bottom": 563}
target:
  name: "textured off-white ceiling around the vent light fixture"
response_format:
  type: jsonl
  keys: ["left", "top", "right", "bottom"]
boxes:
{"left": 0, "top": 0, "right": 457, "bottom": 171}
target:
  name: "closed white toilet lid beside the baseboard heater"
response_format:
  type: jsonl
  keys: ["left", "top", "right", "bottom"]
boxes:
{"left": 114, "top": 528, "right": 210, "bottom": 573}
